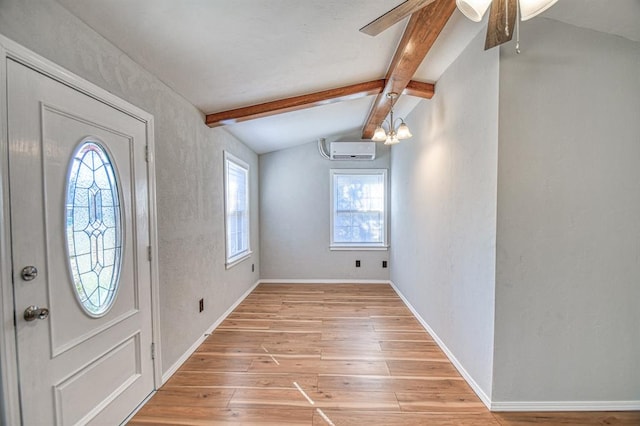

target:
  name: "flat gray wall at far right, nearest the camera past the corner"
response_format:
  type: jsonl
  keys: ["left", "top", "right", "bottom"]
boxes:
{"left": 493, "top": 18, "right": 640, "bottom": 402}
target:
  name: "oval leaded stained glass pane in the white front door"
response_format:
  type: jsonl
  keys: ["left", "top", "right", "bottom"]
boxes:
{"left": 65, "top": 140, "right": 123, "bottom": 317}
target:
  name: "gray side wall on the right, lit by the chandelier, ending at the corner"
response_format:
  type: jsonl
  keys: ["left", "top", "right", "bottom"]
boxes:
{"left": 391, "top": 33, "right": 498, "bottom": 397}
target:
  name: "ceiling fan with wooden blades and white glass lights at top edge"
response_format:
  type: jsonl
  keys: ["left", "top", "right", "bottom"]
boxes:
{"left": 360, "top": 0, "right": 558, "bottom": 50}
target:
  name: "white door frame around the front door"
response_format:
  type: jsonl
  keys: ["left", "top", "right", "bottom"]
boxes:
{"left": 0, "top": 34, "right": 162, "bottom": 425}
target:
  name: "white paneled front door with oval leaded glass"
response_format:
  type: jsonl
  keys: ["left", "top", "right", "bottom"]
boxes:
{"left": 7, "top": 60, "right": 154, "bottom": 426}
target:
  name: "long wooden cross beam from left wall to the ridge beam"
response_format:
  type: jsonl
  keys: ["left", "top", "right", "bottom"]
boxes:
{"left": 205, "top": 80, "right": 385, "bottom": 127}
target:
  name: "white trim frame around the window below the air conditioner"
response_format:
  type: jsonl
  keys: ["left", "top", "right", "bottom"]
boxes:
{"left": 329, "top": 169, "right": 389, "bottom": 251}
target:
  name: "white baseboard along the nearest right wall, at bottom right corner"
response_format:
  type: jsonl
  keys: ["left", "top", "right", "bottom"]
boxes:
{"left": 491, "top": 401, "right": 640, "bottom": 412}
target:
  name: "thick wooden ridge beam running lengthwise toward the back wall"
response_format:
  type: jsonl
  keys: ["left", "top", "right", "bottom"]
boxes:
{"left": 362, "top": 0, "right": 456, "bottom": 139}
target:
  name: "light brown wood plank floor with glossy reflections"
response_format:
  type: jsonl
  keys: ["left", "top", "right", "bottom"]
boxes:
{"left": 129, "top": 284, "right": 640, "bottom": 426}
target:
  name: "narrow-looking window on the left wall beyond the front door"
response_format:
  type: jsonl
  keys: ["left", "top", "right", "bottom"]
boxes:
{"left": 224, "top": 152, "right": 251, "bottom": 268}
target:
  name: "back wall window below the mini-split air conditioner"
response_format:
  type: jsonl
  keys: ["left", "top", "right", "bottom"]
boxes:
{"left": 331, "top": 169, "right": 387, "bottom": 250}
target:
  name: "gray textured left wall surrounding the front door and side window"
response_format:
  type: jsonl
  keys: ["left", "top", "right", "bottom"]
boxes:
{"left": 0, "top": 0, "right": 260, "bottom": 371}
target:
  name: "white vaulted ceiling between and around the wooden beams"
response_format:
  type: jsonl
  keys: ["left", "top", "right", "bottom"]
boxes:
{"left": 58, "top": 0, "right": 640, "bottom": 153}
